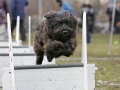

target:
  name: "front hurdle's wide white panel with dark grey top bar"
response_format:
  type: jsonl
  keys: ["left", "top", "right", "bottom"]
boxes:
{"left": 2, "top": 64, "right": 95, "bottom": 90}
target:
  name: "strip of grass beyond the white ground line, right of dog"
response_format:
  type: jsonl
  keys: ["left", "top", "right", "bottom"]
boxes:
{"left": 74, "top": 34, "right": 120, "bottom": 57}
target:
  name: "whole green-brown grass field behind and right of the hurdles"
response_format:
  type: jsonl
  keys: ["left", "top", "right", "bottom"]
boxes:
{"left": 4, "top": 34, "right": 120, "bottom": 90}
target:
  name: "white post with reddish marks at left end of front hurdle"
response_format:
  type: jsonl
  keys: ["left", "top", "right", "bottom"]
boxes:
{"left": 7, "top": 13, "right": 15, "bottom": 90}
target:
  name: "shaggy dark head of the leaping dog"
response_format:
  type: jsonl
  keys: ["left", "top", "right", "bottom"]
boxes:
{"left": 44, "top": 11, "right": 77, "bottom": 41}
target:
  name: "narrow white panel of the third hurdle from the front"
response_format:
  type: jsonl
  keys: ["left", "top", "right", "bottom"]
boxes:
{"left": 0, "top": 46, "right": 34, "bottom": 54}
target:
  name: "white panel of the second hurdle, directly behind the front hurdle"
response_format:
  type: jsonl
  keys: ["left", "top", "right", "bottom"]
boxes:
{"left": 0, "top": 53, "right": 55, "bottom": 87}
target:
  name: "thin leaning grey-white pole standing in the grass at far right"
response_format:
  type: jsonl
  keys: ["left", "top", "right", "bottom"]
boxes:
{"left": 108, "top": 0, "right": 116, "bottom": 54}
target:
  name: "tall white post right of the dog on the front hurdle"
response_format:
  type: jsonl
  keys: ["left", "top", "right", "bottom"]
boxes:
{"left": 82, "top": 12, "right": 88, "bottom": 90}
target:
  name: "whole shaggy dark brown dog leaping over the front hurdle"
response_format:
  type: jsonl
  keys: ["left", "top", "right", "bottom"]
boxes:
{"left": 34, "top": 11, "right": 77, "bottom": 64}
